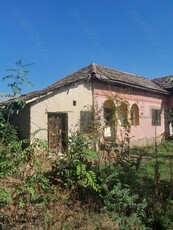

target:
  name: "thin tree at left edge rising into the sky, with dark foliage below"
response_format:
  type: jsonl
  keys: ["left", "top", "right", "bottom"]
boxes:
{"left": 0, "top": 60, "right": 32, "bottom": 144}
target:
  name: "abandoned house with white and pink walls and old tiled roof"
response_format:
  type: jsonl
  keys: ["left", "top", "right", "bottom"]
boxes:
{"left": 1, "top": 64, "right": 173, "bottom": 150}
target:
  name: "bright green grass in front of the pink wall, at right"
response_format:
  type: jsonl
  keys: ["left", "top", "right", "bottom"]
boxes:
{"left": 131, "top": 140, "right": 173, "bottom": 181}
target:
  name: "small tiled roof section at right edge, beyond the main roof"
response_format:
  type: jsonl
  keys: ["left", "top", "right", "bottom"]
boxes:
{"left": 153, "top": 75, "right": 173, "bottom": 90}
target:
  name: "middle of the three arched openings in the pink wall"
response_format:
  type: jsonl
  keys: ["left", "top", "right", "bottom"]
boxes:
{"left": 118, "top": 102, "right": 128, "bottom": 126}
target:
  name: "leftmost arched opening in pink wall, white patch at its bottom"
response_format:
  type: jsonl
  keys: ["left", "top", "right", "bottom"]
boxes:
{"left": 103, "top": 100, "right": 115, "bottom": 139}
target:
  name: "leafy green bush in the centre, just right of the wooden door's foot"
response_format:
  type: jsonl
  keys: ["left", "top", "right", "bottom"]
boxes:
{"left": 49, "top": 133, "right": 100, "bottom": 192}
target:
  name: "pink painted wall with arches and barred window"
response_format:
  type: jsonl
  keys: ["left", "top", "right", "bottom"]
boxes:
{"left": 93, "top": 83, "right": 167, "bottom": 144}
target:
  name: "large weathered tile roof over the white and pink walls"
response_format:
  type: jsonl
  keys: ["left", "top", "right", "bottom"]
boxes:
{"left": 0, "top": 64, "right": 169, "bottom": 105}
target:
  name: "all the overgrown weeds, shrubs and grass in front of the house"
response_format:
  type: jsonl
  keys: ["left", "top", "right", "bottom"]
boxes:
{"left": 0, "top": 61, "right": 173, "bottom": 230}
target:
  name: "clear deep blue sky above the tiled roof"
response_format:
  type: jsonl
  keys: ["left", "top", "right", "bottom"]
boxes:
{"left": 0, "top": 0, "right": 173, "bottom": 93}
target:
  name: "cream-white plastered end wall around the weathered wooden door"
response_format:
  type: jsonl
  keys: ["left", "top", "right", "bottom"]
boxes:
{"left": 30, "top": 82, "right": 93, "bottom": 140}
